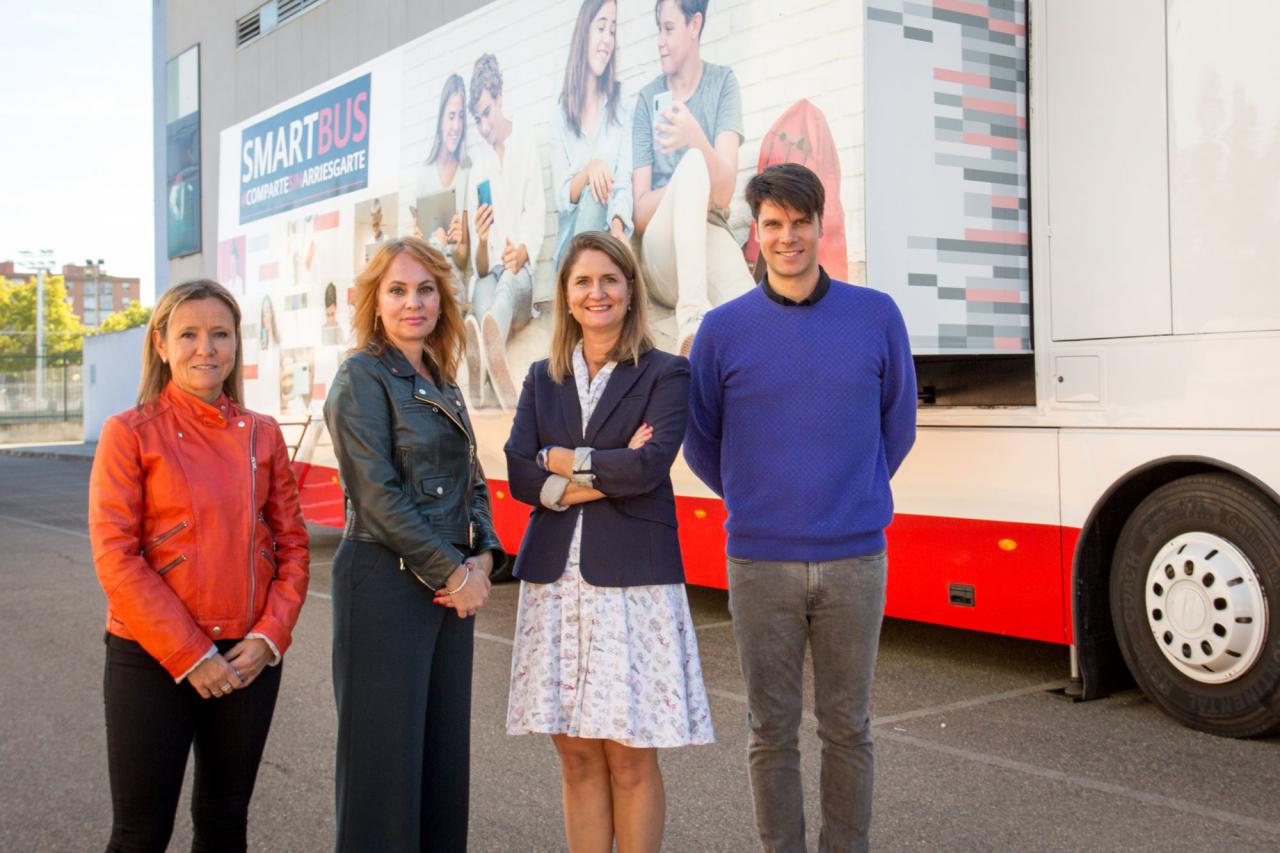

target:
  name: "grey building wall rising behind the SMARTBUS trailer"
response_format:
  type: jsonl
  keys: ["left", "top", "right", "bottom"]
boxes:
{"left": 154, "top": 0, "right": 488, "bottom": 286}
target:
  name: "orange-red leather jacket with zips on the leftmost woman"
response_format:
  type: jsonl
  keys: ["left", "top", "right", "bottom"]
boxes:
{"left": 88, "top": 383, "right": 310, "bottom": 678}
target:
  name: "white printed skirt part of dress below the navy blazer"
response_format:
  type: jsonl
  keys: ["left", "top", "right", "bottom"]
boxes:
{"left": 507, "top": 550, "right": 716, "bottom": 748}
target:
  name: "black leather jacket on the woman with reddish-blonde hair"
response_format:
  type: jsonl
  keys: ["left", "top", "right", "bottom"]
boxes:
{"left": 324, "top": 347, "right": 504, "bottom": 589}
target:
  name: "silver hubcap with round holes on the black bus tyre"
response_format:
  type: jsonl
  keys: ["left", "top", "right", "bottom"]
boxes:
{"left": 1146, "top": 532, "right": 1267, "bottom": 684}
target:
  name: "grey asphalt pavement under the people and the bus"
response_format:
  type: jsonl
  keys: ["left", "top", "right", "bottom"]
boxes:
{"left": 0, "top": 453, "right": 1280, "bottom": 853}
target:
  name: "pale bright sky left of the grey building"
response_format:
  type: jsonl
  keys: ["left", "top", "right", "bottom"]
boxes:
{"left": 0, "top": 0, "right": 155, "bottom": 304}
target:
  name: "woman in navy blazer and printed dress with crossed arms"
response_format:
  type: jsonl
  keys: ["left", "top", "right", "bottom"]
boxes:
{"left": 506, "top": 232, "right": 714, "bottom": 852}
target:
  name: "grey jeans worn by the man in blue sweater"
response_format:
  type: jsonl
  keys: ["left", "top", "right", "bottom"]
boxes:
{"left": 728, "top": 552, "right": 888, "bottom": 853}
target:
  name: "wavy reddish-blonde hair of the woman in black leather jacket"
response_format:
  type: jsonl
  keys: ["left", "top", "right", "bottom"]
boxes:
{"left": 351, "top": 237, "right": 465, "bottom": 383}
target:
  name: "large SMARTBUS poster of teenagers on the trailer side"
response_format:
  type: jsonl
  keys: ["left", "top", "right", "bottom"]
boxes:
{"left": 219, "top": 0, "right": 1029, "bottom": 494}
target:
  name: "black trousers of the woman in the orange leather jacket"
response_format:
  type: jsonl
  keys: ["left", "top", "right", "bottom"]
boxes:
{"left": 102, "top": 634, "right": 283, "bottom": 853}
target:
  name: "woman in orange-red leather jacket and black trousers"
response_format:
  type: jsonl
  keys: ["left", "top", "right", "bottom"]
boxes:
{"left": 88, "top": 280, "right": 308, "bottom": 850}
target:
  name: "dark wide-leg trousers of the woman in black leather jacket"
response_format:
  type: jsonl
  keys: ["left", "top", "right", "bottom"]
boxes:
{"left": 333, "top": 540, "right": 475, "bottom": 853}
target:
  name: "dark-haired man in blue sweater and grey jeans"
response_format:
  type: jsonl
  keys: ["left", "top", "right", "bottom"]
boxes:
{"left": 685, "top": 164, "right": 915, "bottom": 852}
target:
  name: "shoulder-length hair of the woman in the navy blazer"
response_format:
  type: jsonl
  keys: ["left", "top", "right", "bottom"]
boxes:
{"left": 547, "top": 231, "right": 653, "bottom": 383}
